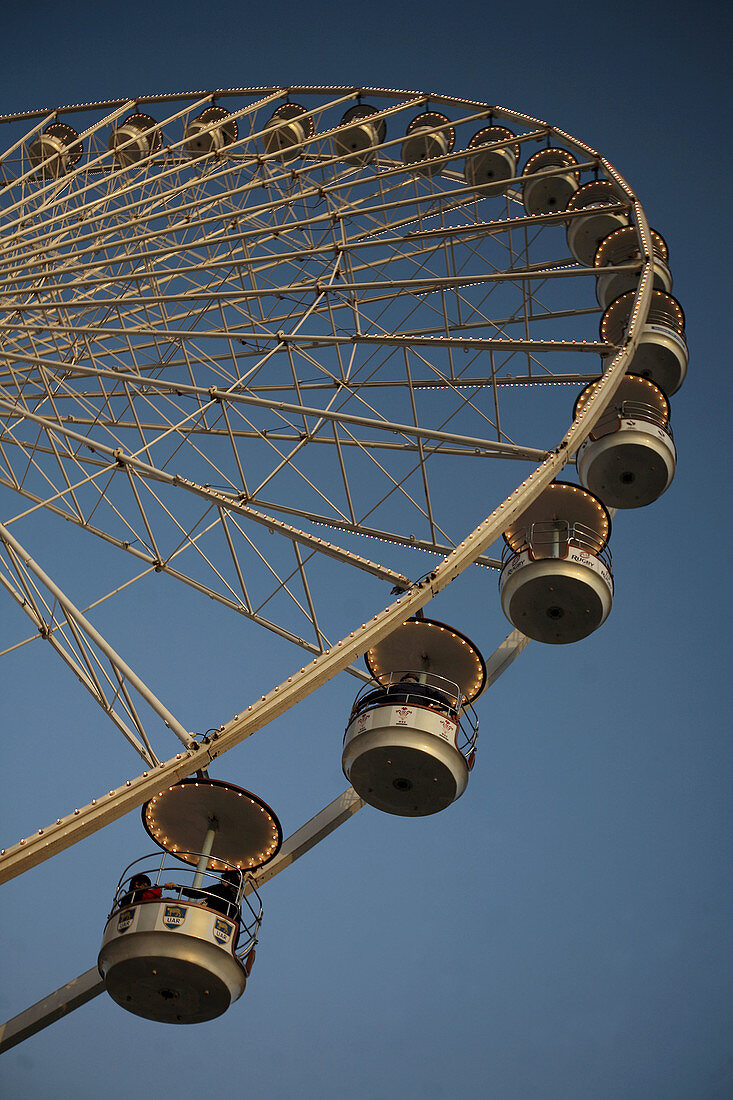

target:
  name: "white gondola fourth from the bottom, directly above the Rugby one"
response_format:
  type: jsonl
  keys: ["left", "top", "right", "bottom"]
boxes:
{"left": 573, "top": 374, "right": 677, "bottom": 508}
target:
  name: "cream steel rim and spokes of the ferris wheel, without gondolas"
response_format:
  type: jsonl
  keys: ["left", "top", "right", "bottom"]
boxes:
{"left": 0, "top": 87, "right": 653, "bottom": 862}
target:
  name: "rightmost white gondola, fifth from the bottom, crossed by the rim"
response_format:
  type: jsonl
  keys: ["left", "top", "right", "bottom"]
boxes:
{"left": 600, "top": 290, "right": 689, "bottom": 396}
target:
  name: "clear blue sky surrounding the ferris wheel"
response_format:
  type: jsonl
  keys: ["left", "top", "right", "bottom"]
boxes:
{"left": 0, "top": 0, "right": 733, "bottom": 1100}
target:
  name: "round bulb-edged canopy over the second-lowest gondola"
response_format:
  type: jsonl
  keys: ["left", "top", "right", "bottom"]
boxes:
{"left": 364, "top": 616, "right": 486, "bottom": 703}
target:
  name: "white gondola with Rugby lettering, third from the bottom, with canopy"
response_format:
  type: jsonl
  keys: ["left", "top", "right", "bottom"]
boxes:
{"left": 499, "top": 482, "right": 613, "bottom": 645}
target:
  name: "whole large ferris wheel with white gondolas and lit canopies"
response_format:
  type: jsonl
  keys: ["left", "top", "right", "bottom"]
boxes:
{"left": 0, "top": 87, "right": 688, "bottom": 1038}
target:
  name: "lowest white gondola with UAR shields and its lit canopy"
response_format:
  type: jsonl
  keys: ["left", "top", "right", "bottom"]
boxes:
{"left": 98, "top": 779, "right": 282, "bottom": 1024}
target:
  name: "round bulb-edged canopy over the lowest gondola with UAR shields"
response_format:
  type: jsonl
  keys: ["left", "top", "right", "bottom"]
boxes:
{"left": 141, "top": 779, "right": 283, "bottom": 871}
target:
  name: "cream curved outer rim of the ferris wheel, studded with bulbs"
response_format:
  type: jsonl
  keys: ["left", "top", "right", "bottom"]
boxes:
{"left": 0, "top": 86, "right": 652, "bottom": 881}
